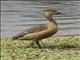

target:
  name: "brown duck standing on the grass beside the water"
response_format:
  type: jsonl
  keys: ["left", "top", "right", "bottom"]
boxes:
{"left": 13, "top": 9, "right": 60, "bottom": 48}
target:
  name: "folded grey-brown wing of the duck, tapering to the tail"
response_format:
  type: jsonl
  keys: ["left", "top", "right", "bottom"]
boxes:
{"left": 13, "top": 25, "right": 47, "bottom": 40}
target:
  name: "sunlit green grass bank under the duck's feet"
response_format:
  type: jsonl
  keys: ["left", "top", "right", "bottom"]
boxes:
{"left": 1, "top": 36, "right": 80, "bottom": 60}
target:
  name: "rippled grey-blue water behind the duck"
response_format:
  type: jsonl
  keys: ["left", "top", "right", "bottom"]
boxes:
{"left": 1, "top": 1, "right": 80, "bottom": 35}
